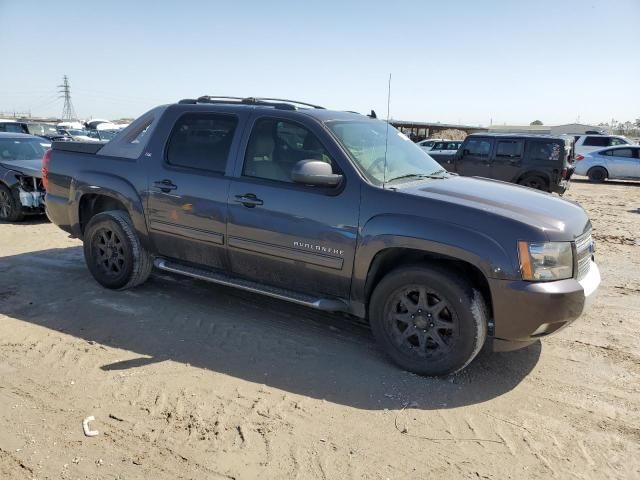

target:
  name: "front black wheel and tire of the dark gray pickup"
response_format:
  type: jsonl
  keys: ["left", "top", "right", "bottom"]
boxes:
{"left": 369, "top": 266, "right": 488, "bottom": 376}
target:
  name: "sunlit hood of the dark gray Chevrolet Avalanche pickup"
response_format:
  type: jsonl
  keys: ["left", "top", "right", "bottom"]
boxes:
{"left": 396, "top": 175, "right": 591, "bottom": 241}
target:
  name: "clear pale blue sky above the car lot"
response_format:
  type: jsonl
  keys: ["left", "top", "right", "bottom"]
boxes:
{"left": 0, "top": 0, "right": 640, "bottom": 125}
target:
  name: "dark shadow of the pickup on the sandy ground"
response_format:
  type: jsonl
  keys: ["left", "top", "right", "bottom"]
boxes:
{"left": 0, "top": 247, "right": 541, "bottom": 410}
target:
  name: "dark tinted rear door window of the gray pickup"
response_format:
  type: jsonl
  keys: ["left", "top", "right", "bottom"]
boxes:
{"left": 167, "top": 113, "right": 238, "bottom": 173}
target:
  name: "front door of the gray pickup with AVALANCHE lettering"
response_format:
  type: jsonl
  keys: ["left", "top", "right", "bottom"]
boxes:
{"left": 227, "top": 112, "right": 360, "bottom": 297}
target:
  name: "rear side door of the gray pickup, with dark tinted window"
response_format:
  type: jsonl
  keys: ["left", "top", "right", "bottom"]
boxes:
{"left": 148, "top": 112, "right": 241, "bottom": 269}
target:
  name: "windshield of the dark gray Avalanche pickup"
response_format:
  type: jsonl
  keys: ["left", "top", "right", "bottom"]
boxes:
{"left": 327, "top": 120, "right": 443, "bottom": 185}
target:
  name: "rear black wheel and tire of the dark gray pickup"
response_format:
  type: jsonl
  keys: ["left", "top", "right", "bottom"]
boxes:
{"left": 84, "top": 210, "right": 153, "bottom": 290}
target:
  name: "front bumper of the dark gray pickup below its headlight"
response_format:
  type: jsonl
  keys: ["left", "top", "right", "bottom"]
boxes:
{"left": 489, "top": 260, "right": 600, "bottom": 351}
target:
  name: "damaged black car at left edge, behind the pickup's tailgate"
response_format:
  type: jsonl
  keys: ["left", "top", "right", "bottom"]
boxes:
{"left": 0, "top": 132, "right": 51, "bottom": 222}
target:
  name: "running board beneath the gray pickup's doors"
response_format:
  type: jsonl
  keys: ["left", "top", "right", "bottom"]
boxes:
{"left": 153, "top": 258, "right": 349, "bottom": 312}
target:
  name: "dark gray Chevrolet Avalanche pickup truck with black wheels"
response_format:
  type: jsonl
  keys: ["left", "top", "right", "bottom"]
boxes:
{"left": 43, "top": 97, "right": 600, "bottom": 375}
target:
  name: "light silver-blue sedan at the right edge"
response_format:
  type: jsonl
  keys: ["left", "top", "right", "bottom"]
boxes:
{"left": 575, "top": 145, "right": 640, "bottom": 183}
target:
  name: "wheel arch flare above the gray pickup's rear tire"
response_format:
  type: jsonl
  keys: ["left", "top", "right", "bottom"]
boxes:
{"left": 69, "top": 172, "right": 149, "bottom": 248}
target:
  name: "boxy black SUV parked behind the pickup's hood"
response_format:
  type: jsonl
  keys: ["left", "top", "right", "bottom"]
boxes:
{"left": 434, "top": 133, "right": 575, "bottom": 194}
